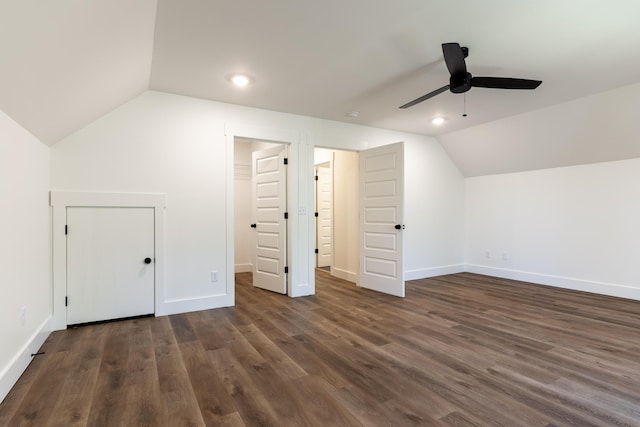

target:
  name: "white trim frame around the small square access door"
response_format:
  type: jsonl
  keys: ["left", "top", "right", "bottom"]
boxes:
{"left": 49, "top": 191, "right": 168, "bottom": 330}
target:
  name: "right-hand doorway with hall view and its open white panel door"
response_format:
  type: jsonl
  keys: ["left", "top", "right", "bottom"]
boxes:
{"left": 314, "top": 142, "right": 405, "bottom": 297}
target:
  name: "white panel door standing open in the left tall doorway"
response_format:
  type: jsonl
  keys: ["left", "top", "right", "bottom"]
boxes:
{"left": 251, "top": 145, "right": 287, "bottom": 294}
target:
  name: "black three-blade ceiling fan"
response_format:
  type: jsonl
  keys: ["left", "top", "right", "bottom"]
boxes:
{"left": 400, "top": 43, "right": 542, "bottom": 108}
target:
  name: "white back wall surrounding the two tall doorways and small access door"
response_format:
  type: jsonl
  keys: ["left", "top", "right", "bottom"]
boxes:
{"left": 51, "top": 91, "right": 464, "bottom": 309}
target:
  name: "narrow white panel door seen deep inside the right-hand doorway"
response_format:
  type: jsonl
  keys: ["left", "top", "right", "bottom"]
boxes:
{"left": 316, "top": 163, "right": 333, "bottom": 267}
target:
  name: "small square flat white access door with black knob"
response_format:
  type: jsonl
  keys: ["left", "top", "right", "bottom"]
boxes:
{"left": 67, "top": 207, "right": 155, "bottom": 325}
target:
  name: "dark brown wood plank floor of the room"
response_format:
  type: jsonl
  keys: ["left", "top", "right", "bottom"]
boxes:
{"left": 0, "top": 271, "right": 640, "bottom": 427}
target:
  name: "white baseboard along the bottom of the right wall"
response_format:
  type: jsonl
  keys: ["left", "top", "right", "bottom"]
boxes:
{"left": 466, "top": 264, "right": 640, "bottom": 301}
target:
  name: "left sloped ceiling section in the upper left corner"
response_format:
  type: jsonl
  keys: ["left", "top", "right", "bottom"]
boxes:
{"left": 0, "top": 0, "right": 156, "bottom": 145}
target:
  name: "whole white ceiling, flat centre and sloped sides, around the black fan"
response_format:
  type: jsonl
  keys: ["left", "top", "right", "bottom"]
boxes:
{"left": 0, "top": 0, "right": 640, "bottom": 176}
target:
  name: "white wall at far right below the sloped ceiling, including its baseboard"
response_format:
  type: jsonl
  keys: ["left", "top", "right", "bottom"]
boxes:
{"left": 466, "top": 159, "right": 640, "bottom": 299}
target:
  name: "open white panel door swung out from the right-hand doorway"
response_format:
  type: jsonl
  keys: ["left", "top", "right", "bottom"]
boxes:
{"left": 360, "top": 143, "right": 404, "bottom": 297}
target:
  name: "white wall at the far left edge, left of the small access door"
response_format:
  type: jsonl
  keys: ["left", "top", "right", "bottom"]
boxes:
{"left": 0, "top": 111, "right": 51, "bottom": 400}
